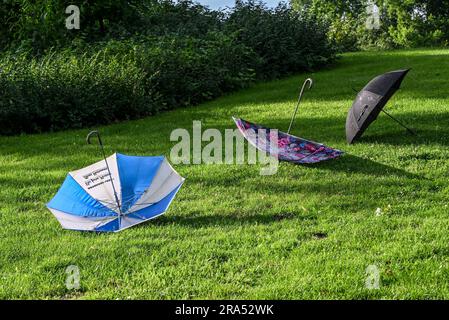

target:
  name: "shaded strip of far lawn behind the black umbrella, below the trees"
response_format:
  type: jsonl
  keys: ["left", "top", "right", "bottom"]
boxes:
{"left": 206, "top": 52, "right": 448, "bottom": 108}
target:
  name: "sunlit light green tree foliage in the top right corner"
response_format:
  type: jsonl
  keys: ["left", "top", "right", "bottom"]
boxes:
{"left": 291, "top": 0, "right": 449, "bottom": 50}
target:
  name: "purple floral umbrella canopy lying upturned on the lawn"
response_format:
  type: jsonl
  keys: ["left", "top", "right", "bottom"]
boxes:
{"left": 233, "top": 118, "right": 344, "bottom": 163}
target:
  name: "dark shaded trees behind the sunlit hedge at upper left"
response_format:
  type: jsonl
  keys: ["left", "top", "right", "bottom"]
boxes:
{"left": 0, "top": 0, "right": 223, "bottom": 54}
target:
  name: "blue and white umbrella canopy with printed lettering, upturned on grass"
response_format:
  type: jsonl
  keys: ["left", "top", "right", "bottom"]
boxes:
{"left": 47, "top": 153, "right": 184, "bottom": 232}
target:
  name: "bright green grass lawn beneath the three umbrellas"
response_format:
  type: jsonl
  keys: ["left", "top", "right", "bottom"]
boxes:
{"left": 0, "top": 50, "right": 449, "bottom": 299}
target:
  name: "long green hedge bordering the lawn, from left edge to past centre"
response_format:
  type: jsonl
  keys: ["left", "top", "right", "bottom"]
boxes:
{"left": 0, "top": 0, "right": 335, "bottom": 135}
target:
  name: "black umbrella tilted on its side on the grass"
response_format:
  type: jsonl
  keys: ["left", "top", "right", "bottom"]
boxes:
{"left": 346, "top": 69, "right": 414, "bottom": 143}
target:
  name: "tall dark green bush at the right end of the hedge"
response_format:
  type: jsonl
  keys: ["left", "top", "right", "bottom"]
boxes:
{"left": 224, "top": 0, "right": 335, "bottom": 78}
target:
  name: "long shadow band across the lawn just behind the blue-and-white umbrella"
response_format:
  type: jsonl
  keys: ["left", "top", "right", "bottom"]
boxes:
{"left": 0, "top": 112, "right": 449, "bottom": 161}
